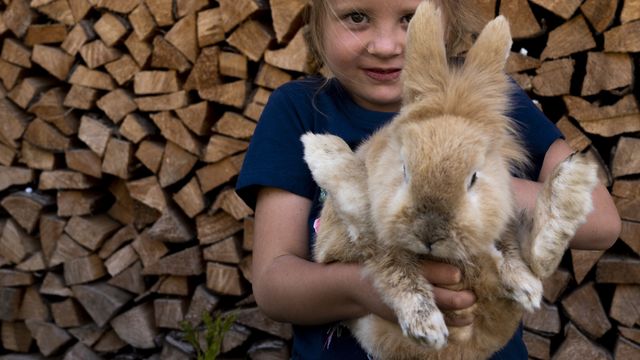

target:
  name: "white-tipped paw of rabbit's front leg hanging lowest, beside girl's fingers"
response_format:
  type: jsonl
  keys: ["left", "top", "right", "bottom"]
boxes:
{"left": 398, "top": 301, "right": 449, "bottom": 349}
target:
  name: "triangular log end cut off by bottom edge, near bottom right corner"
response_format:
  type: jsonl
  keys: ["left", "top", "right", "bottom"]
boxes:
{"left": 553, "top": 323, "right": 613, "bottom": 360}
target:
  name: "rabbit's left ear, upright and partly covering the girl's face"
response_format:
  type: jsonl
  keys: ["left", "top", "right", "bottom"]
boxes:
{"left": 403, "top": 1, "right": 449, "bottom": 104}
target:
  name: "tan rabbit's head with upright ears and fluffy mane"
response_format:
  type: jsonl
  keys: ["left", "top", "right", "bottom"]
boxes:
{"left": 366, "top": 1, "right": 526, "bottom": 260}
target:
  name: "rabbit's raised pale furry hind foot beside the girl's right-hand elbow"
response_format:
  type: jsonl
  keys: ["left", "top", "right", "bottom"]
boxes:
{"left": 523, "top": 154, "right": 598, "bottom": 279}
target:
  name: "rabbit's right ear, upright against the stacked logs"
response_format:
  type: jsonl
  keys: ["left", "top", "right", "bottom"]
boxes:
{"left": 463, "top": 15, "right": 513, "bottom": 95}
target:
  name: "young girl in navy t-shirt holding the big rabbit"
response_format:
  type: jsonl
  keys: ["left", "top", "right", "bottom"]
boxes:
{"left": 237, "top": 0, "right": 620, "bottom": 359}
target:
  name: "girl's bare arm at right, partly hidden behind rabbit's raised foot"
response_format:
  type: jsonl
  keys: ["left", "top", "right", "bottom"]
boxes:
{"left": 513, "top": 139, "right": 622, "bottom": 250}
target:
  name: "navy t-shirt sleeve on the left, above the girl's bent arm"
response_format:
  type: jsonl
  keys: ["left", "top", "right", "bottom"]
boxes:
{"left": 236, "top": 85, "right": 314, "bottom": 208}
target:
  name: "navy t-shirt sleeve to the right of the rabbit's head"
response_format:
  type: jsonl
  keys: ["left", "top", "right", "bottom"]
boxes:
{"left": 508, "top": 84, "right": 563, "bottom": 180}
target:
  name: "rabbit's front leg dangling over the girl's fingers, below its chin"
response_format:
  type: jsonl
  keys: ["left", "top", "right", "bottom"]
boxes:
{"left": 365, "top": 250, "right": 449, "bottom": 349}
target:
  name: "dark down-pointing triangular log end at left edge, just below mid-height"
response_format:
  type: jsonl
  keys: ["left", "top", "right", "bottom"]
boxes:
{"left": 0, "top": 191, "right": 54, "bottom": 233}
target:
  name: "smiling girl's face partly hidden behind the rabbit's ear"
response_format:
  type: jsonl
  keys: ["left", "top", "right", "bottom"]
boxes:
{"left": 322, "top": 0, "right": 422, "bottom": 111}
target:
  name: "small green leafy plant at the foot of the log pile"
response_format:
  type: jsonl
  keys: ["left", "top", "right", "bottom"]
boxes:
{"left": 180, "top": 311, "right": 236, "bottom": 360}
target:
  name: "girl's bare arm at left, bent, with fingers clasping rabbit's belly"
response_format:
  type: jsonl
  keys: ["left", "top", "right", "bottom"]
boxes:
{"left": 252, "top": 188, "right": 475, "bottom": 326}
